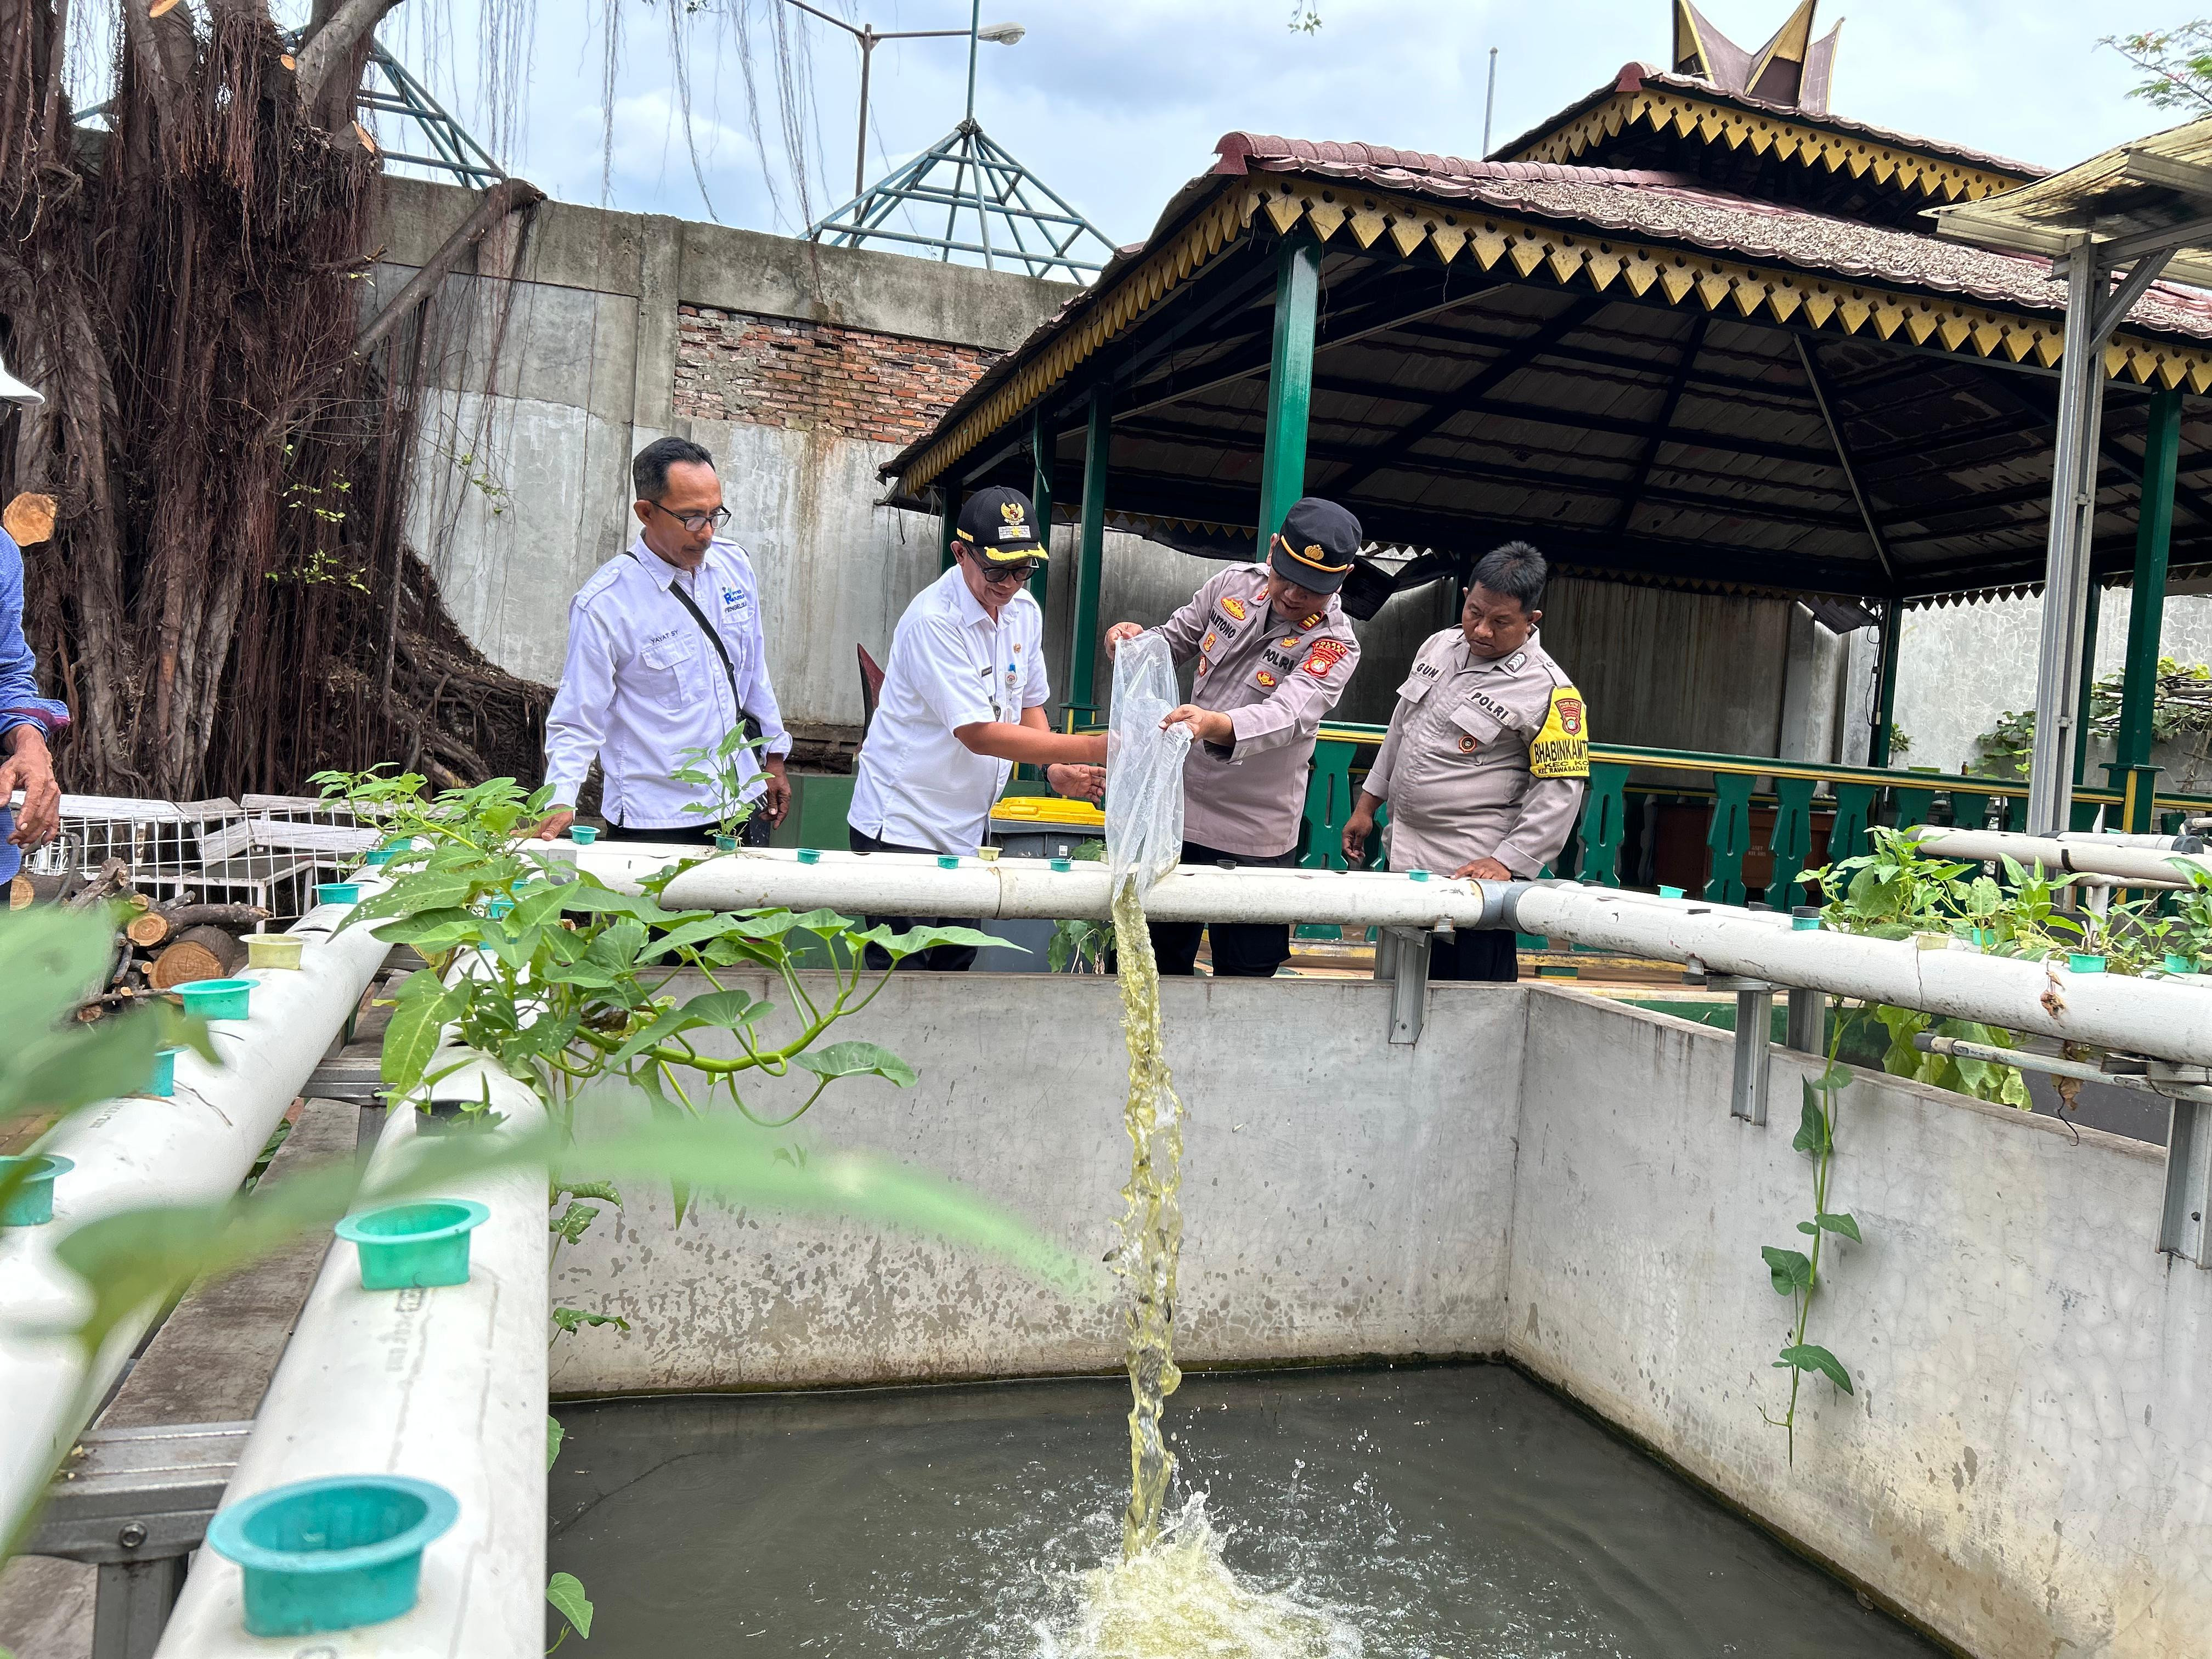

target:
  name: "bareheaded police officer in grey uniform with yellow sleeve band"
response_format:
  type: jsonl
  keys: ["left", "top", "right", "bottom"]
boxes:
{"left": 1345, "top": 542, "right": 1590, "bottom": 980}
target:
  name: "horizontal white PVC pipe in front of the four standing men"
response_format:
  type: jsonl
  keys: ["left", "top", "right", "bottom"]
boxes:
{"left": 654, "top": 847, "right": 1498, "bottom": 927}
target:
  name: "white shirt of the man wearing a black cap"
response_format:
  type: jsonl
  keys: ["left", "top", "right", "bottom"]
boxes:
{"left": 845, "top": 566, "right": 1053, "bottom": 856}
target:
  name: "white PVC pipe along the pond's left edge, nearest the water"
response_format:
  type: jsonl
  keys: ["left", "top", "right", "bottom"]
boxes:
{"left": 155, "top": 1048, "right": 546, "bottom": 1659}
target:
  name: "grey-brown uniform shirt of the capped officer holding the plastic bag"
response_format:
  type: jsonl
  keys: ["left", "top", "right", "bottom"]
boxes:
{"left": 1159, "top": 564, "right": 1361, "bottom": 858}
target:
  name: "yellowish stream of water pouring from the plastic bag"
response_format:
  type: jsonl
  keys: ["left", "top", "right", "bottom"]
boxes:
{"left": 1113, "top": 878, "right": 1186, "bottom": 1575}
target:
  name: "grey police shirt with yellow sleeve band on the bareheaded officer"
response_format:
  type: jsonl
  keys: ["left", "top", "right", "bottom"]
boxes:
{"left": 1361, "top": 626, "right": 1590, "bottom": 878}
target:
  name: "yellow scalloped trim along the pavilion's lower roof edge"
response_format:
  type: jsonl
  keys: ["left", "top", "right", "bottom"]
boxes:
{"left": 900, "top": 175, "right": 2212, "bottom": 506}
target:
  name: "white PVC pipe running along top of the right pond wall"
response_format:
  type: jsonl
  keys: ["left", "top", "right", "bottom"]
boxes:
{"left": 1500, "top": 883, "right": 2212, "bottom": 1066}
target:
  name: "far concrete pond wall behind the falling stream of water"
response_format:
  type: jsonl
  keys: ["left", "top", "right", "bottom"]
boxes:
{"left": 553, "top": 973, "right": 1526, "bottom": 1393}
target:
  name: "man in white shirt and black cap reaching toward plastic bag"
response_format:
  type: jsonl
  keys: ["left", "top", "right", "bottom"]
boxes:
{"left": 845, "top": 489, "right": 1106, "bottom": 971}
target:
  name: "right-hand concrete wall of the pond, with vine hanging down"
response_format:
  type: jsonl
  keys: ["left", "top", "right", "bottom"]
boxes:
{"left": 1506, "top": 993, "right": 2212, "bottom": 1659}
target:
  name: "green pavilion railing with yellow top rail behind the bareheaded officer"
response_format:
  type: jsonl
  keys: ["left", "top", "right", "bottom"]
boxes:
{"left": 1301, "top": 723, "right": 2212, "bottom": 907}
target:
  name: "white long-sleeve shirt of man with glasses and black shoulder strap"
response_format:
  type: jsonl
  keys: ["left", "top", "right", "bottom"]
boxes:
{"left": 546, "top": 538, "right": 792, "bottom": 830}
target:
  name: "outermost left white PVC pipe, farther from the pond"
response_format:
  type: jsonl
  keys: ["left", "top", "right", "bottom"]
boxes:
{"left": 0, "top": 883, "right": 392, "bottom": 1557}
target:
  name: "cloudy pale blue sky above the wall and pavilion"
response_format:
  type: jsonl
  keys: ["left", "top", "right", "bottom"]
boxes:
{"left": 336, "top": 0, "right": 2212, "bottom": 263}
